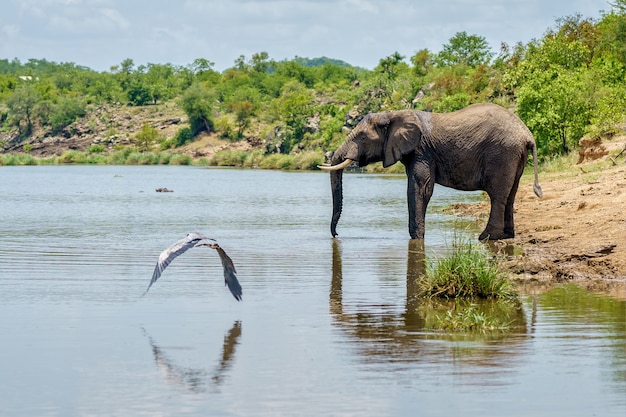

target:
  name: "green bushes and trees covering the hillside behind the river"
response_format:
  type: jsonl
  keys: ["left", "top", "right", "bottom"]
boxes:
{"left": 0, "top": 0, "right": 626, "bottom": 169}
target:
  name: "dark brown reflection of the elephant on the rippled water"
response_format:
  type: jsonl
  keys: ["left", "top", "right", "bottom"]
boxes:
{"left": 329, "top": 239, "right": 529, "bottom": 372}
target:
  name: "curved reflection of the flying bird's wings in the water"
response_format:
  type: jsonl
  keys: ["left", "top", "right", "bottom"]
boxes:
{"left": 143, "top": 321, "right": 241, "bottom": 393}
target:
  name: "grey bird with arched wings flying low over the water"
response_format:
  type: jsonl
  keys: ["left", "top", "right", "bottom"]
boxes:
{"left": 142, "top": 232, "right": 242, "bottom": 301}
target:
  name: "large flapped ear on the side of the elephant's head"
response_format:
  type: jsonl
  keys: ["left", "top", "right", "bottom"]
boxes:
{"left": 383, "top": 113, "right": 422, "bottom": 168}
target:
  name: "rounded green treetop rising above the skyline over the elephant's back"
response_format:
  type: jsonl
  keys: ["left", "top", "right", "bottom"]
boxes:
{"left": 435, "top": 32, "right": 493, "bottom": 67}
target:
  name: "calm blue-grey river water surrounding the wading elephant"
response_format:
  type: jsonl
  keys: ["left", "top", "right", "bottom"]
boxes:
{"left": 0, "top": 166, "right": 626, "bottom": 417}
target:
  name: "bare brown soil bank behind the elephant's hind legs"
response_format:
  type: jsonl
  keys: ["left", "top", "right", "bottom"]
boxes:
{"left": 446, "top": 137, "right": 626, "bottom": 299}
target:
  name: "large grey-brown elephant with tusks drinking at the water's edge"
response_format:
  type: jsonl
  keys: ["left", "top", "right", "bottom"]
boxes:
{"left": 319, "top": 103, "right": 543, "bottom": 240}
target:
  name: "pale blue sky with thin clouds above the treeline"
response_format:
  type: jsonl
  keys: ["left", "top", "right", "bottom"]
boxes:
{"left": 0, "top": 0, "right": 611, "bottom": 72}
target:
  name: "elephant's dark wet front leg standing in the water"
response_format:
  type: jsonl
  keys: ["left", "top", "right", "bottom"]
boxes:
{"left": 407, "top": 161, "right": 435, "bottom": 240}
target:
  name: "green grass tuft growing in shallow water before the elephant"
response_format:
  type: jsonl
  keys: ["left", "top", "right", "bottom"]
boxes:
{"left": 418, "top": 238, "right": 515, "bottom": 298}
